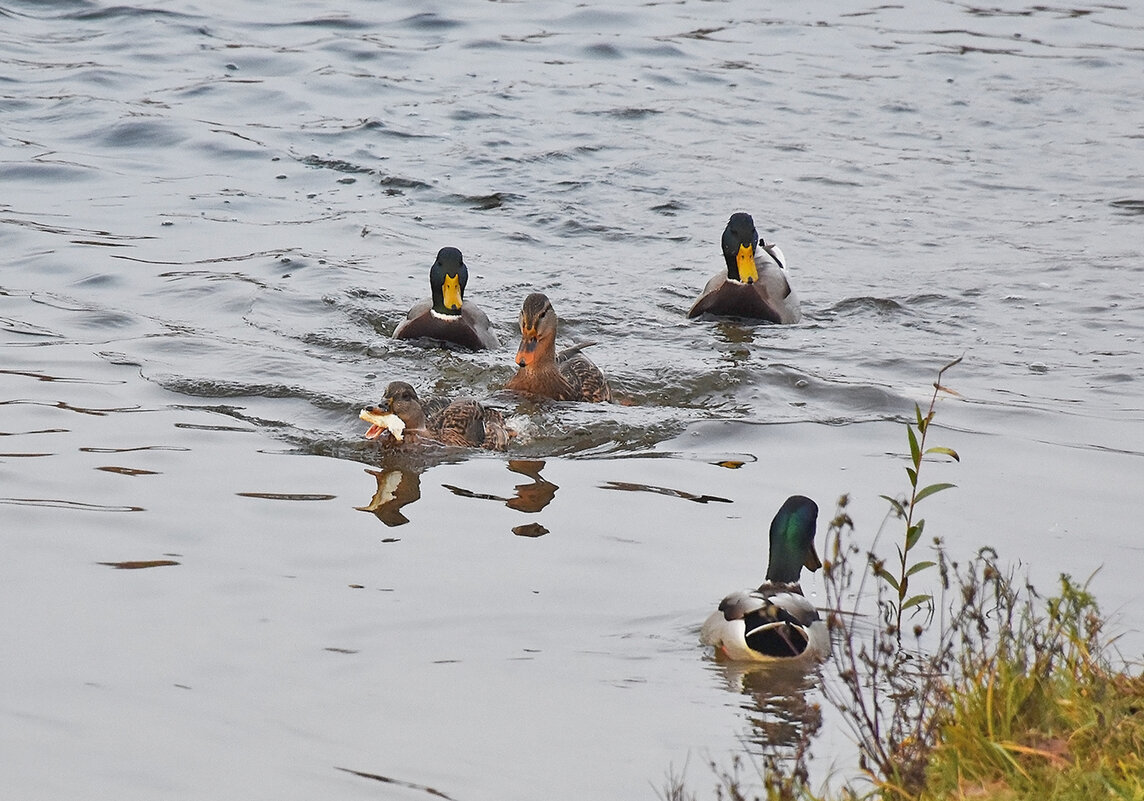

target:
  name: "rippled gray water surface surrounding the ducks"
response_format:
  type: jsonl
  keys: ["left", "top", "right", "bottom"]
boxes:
{"left": 0, "top": 0, "right": 1144, "bottom": 801}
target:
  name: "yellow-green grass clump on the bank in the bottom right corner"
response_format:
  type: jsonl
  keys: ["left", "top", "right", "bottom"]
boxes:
{"left": 919, "top": 560, "right": 1144, "bottom": 801}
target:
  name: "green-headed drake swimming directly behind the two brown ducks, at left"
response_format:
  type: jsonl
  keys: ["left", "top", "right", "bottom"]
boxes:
{"left": 394, "top": 247, "right": 500, "bottom": 350}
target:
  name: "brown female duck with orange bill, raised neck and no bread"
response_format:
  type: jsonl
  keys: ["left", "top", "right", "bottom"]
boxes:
{"left": 505, "top": 292, "right": 612, "bottom": 403}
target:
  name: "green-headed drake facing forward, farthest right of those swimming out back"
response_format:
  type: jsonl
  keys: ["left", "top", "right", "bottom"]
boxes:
{"left": 688, "top": 212, "right": 802, "bottom": 324}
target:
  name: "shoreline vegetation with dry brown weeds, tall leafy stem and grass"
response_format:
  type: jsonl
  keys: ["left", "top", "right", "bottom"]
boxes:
{"left": 660, "top": 362, "right": 1144, "bottom": 801}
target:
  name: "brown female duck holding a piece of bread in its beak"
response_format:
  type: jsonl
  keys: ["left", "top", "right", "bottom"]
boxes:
{"left": 360, "top": 381, "right": 513, "bottom": 451}
